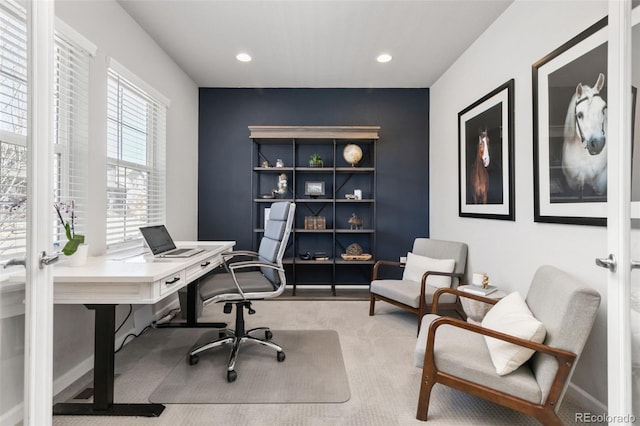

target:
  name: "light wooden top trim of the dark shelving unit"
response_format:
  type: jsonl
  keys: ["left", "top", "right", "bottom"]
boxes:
{"left": 249, "top": 126, "right": 380, "bottom": 139}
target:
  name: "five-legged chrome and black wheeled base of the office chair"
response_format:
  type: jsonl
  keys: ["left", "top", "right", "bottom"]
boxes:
{"left": 188, "top": 301, "right": 286, "bottom": 383}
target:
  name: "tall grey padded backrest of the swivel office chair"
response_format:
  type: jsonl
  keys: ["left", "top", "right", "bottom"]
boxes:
{"left": 258, "top": 202, "right": 296, "bottom": 287}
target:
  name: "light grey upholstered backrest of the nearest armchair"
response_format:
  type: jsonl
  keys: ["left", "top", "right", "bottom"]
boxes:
{"left": 526, "top": 266, "right": 600, "bottom": 406}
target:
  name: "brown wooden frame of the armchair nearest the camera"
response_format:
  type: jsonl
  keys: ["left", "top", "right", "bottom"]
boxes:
{"left": 416, "top": 288, "right": 577, "bottom": 425}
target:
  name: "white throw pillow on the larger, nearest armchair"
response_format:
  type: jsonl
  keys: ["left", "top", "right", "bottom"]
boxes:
{"left": 482, "top": 291, "right": 547, "bottom": 376}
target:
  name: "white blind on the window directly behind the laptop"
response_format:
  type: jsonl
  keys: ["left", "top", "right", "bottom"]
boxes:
{"left": 106, "top": 66, "right": 167, "bottom": 249}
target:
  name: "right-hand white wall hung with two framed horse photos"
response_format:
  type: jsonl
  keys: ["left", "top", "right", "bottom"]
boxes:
{"left": 430, "top": 0, "right": 607, "bottom": 407}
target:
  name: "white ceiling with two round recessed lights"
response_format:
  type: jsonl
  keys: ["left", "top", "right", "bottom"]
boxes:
{"left": 118, "top": 0, "right": 513, "bottom": 88}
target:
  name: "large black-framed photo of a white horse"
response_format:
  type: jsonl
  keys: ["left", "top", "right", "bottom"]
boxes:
{"left": 532, "top": 18, "right": 607, "bottom": 226}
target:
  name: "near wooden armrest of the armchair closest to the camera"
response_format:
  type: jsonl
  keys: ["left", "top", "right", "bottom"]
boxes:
{"left": 423, "top": 317, "right": 577, "bottom": 404}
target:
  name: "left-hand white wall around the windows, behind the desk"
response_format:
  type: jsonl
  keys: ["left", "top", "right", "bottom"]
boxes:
{"left": 54, "top": 0, "right": 198, "bottom": 392}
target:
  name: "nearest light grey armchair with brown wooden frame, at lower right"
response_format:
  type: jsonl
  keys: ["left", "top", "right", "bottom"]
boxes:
{"left": 415, "top": 266, "right": 600, "bottom": 425}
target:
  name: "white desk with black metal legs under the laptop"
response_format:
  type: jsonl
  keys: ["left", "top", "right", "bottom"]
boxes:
{"left": 53, "top": 241, "right": 235, "bottom": 417}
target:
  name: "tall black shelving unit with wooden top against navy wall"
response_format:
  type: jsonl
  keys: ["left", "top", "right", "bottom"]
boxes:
{"left": 249, "top": 126, "right": 380, "bottom": 295}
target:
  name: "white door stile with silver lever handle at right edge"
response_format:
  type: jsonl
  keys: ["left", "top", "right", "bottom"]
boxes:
{"left": 598, "top": 0, "right": 640, "bottom": 424}
